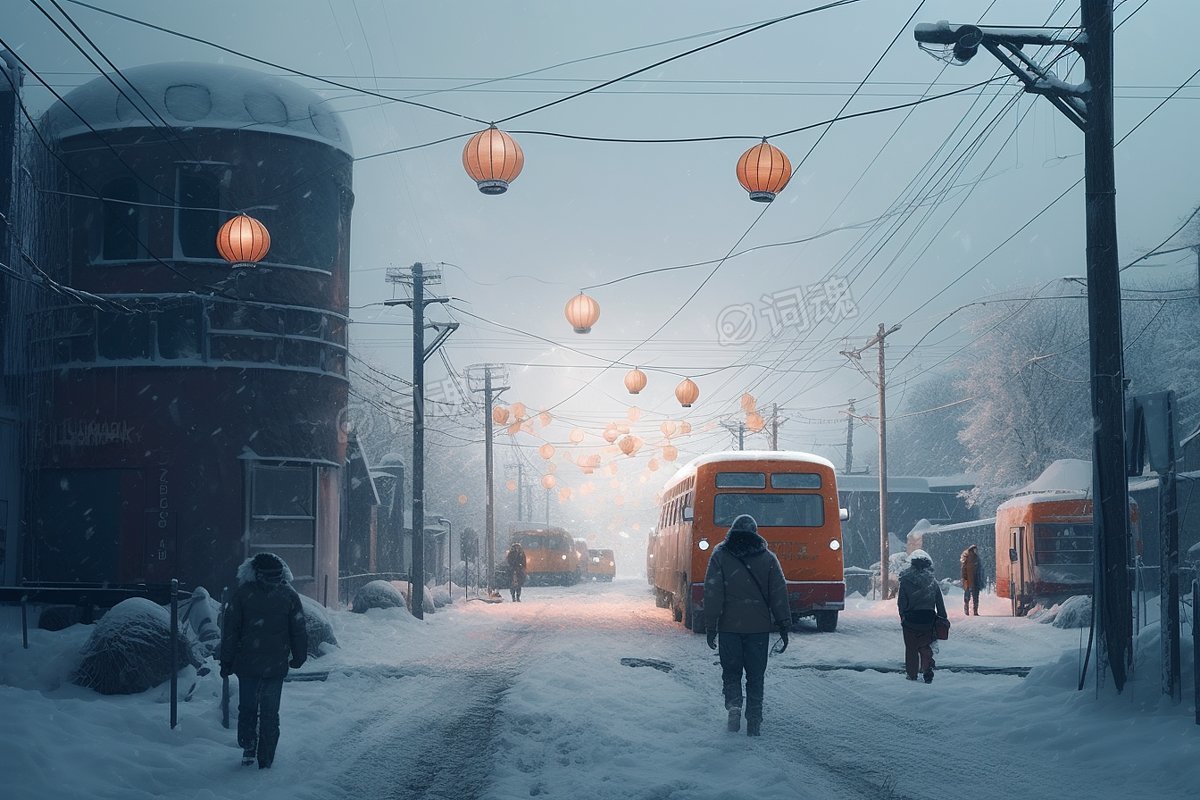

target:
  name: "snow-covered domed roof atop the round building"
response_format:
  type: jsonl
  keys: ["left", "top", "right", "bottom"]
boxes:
{"left": 43, "top": 61, "right": 350, "bottom": 154}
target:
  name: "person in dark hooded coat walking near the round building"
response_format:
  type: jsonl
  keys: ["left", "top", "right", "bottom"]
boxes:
{"left": 221, "top": 553, "right": 308, "bottom": 769}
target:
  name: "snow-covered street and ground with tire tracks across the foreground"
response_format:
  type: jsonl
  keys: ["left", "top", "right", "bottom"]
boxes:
{"left": 0, "top": 579, "right": 1200, "bottom": 800}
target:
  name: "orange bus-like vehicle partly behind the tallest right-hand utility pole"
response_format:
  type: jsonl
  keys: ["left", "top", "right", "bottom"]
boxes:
{"left": 996, "top": 492, "right": 1138, "bottom": 616}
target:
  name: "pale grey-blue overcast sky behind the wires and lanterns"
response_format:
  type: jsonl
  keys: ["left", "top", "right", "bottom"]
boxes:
{"left": 0, "top": 0, "right": 1200, "bottom": 474}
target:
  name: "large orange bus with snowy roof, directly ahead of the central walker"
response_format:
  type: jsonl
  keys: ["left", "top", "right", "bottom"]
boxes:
{"left": 647, "top": 451, "right": 847, "bottom": 631}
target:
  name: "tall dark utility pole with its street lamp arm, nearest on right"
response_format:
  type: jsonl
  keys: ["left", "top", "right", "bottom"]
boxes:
{"left": 914, "top": 0, "right": 1133, "bottom": 692}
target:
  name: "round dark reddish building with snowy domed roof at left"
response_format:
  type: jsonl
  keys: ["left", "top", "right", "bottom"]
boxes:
{"left": 20, "top": 62, "right": 353, "bottom": 599}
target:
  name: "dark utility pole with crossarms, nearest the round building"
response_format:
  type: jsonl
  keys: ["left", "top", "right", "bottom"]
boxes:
{"left": 383, "top": 261, "right": 458, "bottom": 619}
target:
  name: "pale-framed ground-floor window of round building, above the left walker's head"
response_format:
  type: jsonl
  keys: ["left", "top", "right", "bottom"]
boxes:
{"left": 246, "top": 462, "right": 317, "bottom": 581}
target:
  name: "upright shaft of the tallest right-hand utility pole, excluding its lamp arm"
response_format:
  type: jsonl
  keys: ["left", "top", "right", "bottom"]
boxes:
{"left": 1081, "top": 0, "right": 1133, "bottom": 692}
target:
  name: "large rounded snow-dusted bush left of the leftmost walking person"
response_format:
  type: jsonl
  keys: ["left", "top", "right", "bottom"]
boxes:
{"left": 72, "top": 597, "right": 190, "bottom": 694}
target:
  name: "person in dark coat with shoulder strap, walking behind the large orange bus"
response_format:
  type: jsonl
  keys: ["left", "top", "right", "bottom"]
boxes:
{"left": 704, "top": 515, "right": 792, "bottom": 736}
